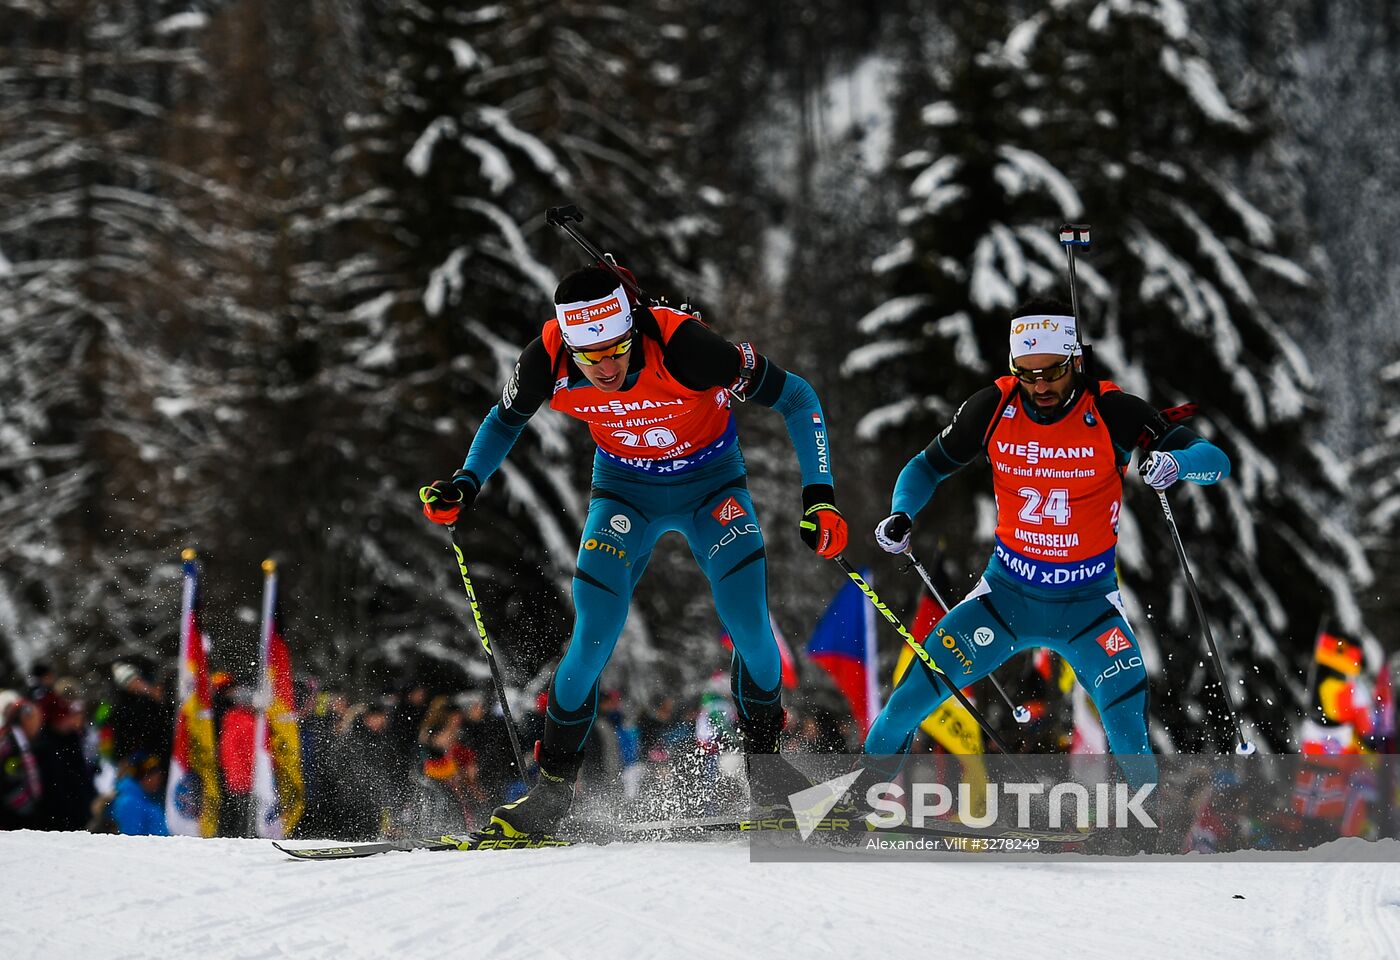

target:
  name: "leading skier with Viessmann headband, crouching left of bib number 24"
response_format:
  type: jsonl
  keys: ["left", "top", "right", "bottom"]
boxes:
{"left": 420, "top": 267, "right": 847, "bottom": 837}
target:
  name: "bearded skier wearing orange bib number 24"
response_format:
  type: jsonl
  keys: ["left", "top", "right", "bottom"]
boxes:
{"left": 865, "top": 301, "right": 1229, "bottom": 782}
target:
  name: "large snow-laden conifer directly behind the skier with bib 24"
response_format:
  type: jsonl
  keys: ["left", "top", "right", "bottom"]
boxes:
{"left": 846, "top": 0, "right": 1371, "bottom": 749}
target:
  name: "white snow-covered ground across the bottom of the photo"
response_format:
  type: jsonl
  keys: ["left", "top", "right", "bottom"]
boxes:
{"left": 8, "top": 831, "right": 1400, "bottom": 960}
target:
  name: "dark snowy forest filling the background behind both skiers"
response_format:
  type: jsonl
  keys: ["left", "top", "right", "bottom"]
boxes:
{"left": 0, "top": 0, "right": 1400, "bottom": 750}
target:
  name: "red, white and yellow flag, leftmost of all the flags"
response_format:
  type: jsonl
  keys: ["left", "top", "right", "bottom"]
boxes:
{"left": 165, "top": 550, "right": 218, "bottom": 837}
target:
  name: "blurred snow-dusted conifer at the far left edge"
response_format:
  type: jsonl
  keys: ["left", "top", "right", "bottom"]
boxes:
{"left": 0, "top": 0, "right": 257, "bottom": 677}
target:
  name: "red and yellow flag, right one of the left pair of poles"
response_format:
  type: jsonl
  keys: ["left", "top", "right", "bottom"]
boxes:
{"left": 253, "top": 560, "right": 307, "bottom": 838}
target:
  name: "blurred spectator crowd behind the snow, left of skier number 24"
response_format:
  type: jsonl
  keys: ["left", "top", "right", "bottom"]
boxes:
{"left": 0, "top": 659, "right": 860, "bottom": 840}
